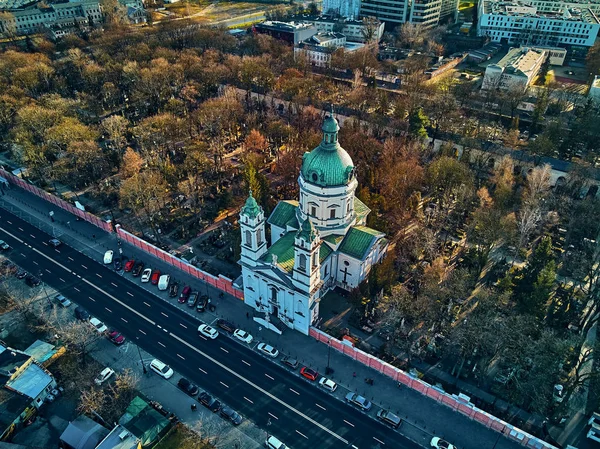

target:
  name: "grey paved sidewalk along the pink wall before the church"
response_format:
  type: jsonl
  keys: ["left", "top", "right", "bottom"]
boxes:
{"left": 0, "top": 186, "right": 521, "bottom": 449}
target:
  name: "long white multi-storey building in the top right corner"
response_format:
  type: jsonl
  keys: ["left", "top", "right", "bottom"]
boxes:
{"left": 477, "top": 0, "right": 600, "bottom": 47}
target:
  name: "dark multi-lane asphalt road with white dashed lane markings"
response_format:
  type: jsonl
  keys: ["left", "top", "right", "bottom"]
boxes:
{"left": 0, "top": 210, "right": 420, "bottom": 449}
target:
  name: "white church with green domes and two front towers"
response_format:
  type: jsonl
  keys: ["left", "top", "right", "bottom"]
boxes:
{"left": 239, "top": 115, "right": 388, "bottom": 334}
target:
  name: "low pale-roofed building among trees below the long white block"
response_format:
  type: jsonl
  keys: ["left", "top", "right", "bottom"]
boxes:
{"left": 481, "top": 47, "right": 548, "bottom": 90}
